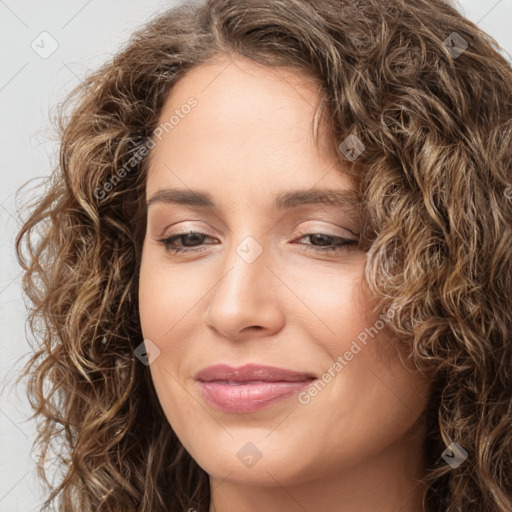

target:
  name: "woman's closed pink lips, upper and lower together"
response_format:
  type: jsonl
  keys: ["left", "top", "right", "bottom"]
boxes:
{"left": 195, "top": 364, "right": 316, "bottom": 412}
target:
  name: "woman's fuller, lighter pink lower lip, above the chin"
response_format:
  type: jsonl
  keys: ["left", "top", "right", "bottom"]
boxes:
{"left": 198, "top": 380, "right": 313, "bottom": 412}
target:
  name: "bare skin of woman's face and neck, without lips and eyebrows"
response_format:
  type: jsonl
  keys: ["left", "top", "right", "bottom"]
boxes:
{"left": 139, "top": 57, "right": 429, "bottom": 512}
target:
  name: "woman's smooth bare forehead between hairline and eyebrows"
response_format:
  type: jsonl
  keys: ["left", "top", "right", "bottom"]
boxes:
{"left": 148, "top": 58, "right": 346, "bottom": 198}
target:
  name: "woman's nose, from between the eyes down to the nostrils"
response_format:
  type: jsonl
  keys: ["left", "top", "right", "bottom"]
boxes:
{"left": 206, "top": 237, "right": 284, "bottom": 340}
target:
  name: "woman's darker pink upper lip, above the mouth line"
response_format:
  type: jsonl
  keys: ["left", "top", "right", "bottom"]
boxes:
{"left": 195, "top": 364, "right": 316, "bottom": 382}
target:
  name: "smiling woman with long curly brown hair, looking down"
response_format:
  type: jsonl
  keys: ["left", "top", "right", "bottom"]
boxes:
{"left": 17, "top": 0, "right": 512, "bottom": 512}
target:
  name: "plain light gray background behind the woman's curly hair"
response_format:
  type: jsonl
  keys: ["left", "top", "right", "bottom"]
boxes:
{"left": 0, "top": 0, "right": 512, "bottom": 512}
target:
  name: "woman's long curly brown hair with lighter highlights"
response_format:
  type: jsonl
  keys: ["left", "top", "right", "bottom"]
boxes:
{"left": 11, "top": 0, "right": 512, "bottom": 512}
